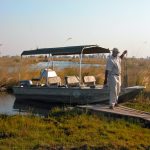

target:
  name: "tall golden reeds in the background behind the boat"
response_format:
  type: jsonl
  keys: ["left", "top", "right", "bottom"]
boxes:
{"left": 0, "top": 57, "right": 150, "bottom": 89}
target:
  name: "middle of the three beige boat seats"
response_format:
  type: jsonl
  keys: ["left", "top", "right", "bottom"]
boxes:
{"left": 65, "top": 76, "right": 80, "bottom": 87}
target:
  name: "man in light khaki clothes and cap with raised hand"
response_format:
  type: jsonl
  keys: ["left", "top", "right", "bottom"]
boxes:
{"left": 104, "top": 48, "right": 127, "bottom": 109}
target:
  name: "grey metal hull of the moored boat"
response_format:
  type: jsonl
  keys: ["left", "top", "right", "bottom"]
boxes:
{"left": 13, "top": 86, "right": 143, "bottom": 104}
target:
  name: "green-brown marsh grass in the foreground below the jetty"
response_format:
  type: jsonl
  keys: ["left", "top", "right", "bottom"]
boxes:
{"left": 0, "top": 108, "right": 150, "bottom": 150}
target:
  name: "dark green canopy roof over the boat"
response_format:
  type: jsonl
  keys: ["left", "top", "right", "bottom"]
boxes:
{"left": 21, "top": 45, "right": 110, "bottom": 56}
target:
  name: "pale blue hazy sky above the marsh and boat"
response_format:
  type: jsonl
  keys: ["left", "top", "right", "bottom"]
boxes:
{"left": 0, "top": 0, "right": 150, "bottom": 57}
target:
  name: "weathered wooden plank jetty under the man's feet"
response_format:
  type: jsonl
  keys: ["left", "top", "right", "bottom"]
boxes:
{"left": 78, "top": 104, "right": 150, "bottom": 127}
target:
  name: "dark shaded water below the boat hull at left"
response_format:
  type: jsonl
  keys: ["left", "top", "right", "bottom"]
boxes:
{"left": 0, "top": 94, "right": 67, "bottom": 117}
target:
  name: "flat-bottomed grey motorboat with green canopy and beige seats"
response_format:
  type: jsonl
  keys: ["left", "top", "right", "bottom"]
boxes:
{"left": 13, "top": 45, "right": 145, "bottom": 105}
